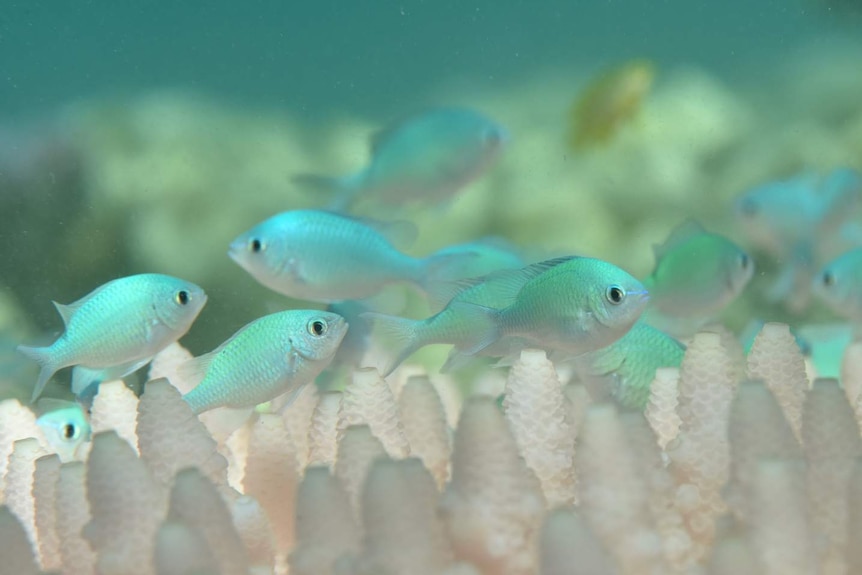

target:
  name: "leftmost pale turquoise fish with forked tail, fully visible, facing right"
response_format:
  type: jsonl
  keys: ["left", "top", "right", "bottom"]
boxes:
{"left": 18, "top": 274, "right": 207, "bottom": 401}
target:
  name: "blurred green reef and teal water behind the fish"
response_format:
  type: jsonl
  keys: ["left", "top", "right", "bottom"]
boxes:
{"left": 0, "top": 0, "right": 862, "bottom": 398}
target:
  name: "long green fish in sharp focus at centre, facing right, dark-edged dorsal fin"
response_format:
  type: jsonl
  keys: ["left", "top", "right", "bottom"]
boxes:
{"left": 368, "top": 257, "right": 649, "bottom": 373}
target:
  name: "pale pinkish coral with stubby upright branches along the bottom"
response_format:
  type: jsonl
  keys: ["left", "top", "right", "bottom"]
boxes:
{"left": 5, "top": 324, "right": 862, "bottom": 575}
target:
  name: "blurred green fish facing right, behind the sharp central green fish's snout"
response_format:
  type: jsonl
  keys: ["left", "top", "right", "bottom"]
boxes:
{"left": 643, "top": 220, "right": 754, "bottom": 334}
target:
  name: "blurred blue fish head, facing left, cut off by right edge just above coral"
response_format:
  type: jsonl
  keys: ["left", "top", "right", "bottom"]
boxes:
{"left": 812, "top": 248, "right": 862, "bottom": 319}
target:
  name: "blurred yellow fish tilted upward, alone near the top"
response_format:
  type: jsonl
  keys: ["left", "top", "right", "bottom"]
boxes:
{"left": 569, "top": 60, "right": 656, "bottom": 151}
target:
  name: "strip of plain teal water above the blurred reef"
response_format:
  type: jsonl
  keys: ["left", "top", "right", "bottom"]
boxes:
{"left": 0, "top": 0, "right": 859, "bottom": 118}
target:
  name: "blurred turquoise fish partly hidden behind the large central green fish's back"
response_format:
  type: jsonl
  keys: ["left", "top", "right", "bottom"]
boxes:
{"left": 426, "top": 237, "right": 527, "bottom": 281}
